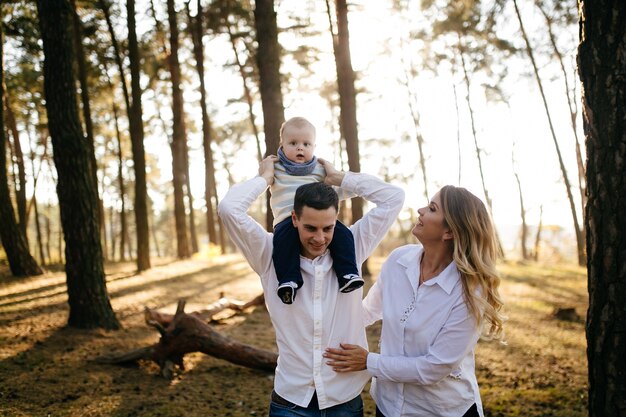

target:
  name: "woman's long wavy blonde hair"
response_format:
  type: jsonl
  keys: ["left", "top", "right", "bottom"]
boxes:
{"left": 439, "top": 185, "right": 503, "bottom": 340}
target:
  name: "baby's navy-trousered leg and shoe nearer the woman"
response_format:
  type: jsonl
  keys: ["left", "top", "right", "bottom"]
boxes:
{"left": 328, "top": 220, "right": 364, "bottom": 292}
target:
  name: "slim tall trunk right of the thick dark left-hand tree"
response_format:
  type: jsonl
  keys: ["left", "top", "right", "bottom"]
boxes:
{"left": 125, "top": 0, "right": 150, "bottom": 271}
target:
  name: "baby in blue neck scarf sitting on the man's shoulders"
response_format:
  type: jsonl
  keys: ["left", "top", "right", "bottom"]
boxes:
{"left": 270, "top": 117, "right": 364, "bottom": 304}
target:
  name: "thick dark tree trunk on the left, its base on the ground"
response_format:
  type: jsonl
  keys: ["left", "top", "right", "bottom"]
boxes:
{"left": 37, "top": 0, "right": 120, "bottom": 329}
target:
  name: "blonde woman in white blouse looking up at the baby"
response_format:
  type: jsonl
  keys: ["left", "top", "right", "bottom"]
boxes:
{"left": 325, "top": 186, "right": 502, "bottom": 417}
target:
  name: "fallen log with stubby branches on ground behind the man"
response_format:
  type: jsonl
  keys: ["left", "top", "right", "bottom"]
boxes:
{"left": 95, "top": 300, "right": 278, "bottom": 379}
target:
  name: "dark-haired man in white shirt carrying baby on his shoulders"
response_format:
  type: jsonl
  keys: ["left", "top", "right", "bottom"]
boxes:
{"left": 218, "top": 155, "right": 404, "bottom": 417}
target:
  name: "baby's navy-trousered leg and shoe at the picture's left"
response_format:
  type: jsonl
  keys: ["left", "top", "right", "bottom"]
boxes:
{"left": 272, "top": 217, "right": 303, "bottom": 304}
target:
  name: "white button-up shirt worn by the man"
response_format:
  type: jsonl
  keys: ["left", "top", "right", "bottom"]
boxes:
{"left": 218, "top": 172, "right": 404, "bottom": 409}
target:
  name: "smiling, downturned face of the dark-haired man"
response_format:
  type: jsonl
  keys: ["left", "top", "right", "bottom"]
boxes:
{"left": 291, "top": 206, "right": 337, "bottom": 259}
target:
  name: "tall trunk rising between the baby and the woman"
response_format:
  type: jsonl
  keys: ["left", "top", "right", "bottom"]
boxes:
{"left": 326, "top": 0, "right": 360, "bottom": 224}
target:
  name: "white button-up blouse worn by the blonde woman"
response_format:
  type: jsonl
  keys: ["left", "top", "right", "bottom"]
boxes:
{"left": 363, "top": 245, "right": 483, "bottom": 417}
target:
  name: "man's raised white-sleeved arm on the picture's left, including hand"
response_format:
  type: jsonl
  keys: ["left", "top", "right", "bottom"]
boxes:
{"left": 217, "top": 155, "right": 278, "bottom": 276}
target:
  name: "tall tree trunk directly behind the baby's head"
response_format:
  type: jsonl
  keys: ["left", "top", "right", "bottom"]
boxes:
{"left": 254, "top": 0, "right": 285, "bottom": 230}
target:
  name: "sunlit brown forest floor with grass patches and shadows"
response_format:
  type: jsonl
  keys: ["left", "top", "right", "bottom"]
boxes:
{"left": 0, "top": 255, "right": 587, "bottom": 417}
